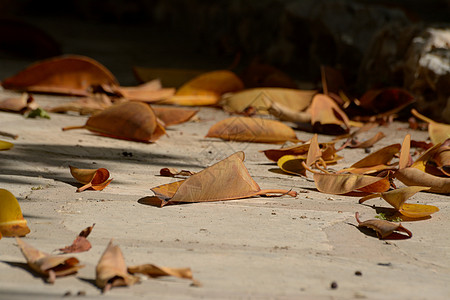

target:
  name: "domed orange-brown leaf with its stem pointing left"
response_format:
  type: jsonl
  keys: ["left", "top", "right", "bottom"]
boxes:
{"left": 63, "top": 101, "right": 166, "bottom": 143}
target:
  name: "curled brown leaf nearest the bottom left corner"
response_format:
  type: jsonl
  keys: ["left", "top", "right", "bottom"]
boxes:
{"left": 16, "top": 237, "right": 84, "bottom": 283}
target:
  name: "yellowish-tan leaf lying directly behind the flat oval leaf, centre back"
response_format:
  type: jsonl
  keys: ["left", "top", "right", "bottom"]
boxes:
{"left": 223, "top": 88, "right": 316, "bottom": 113}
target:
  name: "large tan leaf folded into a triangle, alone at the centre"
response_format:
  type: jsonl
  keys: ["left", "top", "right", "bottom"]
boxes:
{"left": 141, "top": 151, "right": 297, "bottom": 207}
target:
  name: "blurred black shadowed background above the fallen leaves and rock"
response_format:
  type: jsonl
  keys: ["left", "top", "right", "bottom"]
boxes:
{"left": 0, "top": 0, "right": 450, "bottom": 86}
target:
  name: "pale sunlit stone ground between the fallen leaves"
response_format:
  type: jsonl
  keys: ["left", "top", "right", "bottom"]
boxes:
{"left": 0, "top": 17, "right": 450, "bottom": 299}
